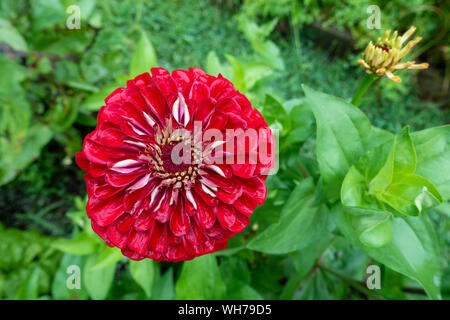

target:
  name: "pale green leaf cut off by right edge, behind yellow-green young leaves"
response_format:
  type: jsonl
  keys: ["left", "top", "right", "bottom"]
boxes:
{"left": 412, "top": 125, "right": 450, "bottom": 200}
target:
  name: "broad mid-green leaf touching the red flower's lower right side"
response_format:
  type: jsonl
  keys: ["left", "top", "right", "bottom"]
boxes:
{"left": 247, "top": 177, "right": 328, "bottom": 254}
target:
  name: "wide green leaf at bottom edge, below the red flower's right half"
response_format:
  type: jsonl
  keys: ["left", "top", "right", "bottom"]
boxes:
{"left": 175, "top": 254, "right": 225, "bottom": 300}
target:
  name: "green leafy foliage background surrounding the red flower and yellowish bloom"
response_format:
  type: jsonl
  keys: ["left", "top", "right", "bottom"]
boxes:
{"left": 0, "top": 0, "right": 450, "bottom": 299}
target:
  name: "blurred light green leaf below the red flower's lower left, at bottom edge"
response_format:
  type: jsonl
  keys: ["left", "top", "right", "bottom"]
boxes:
{"left": 81, "top": 254, "right": 117, "bottom": 300}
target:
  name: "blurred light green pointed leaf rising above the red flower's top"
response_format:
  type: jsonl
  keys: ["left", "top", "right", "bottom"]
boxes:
{"left": 130, "top": 31, "right": 158, "bottom": 77}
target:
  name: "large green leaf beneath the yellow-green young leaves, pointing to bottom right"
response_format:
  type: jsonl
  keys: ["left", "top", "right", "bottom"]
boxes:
{"left": 332, "top": 205, "right": 441, "bottom": 299}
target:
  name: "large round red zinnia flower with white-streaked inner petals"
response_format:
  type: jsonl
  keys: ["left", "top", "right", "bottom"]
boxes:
{"left": 76, "top": 68, "right": 273, "bottom": 261}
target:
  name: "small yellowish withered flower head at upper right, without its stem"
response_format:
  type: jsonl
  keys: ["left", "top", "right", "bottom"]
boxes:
{"left": 358, "top": 26, "right": 428, "bottom": 82}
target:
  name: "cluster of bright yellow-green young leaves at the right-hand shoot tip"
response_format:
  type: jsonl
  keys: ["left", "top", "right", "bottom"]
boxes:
{"left": 341, "top": 128, "right": 441, "bottom": 247}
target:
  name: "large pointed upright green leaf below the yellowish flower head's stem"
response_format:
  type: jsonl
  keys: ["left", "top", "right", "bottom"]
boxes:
{"left": 303, "top": 86, "right": 389, "bottom": 201}
